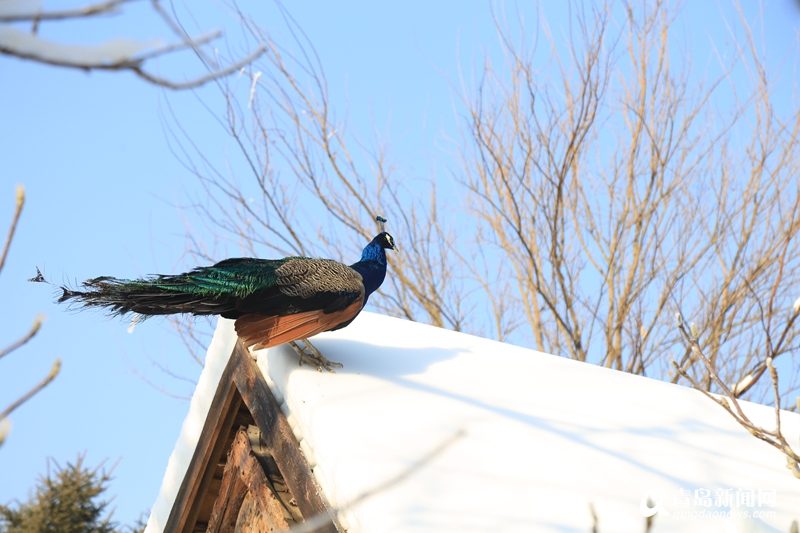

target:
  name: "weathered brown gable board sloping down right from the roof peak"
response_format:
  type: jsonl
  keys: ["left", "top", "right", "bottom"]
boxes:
{"left": 231, "top": 341, "right": 339, "bottom": 533}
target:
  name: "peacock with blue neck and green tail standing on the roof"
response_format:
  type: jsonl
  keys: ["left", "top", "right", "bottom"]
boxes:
{"left": 31, "top": 217, "right": 396, "bottom": 372}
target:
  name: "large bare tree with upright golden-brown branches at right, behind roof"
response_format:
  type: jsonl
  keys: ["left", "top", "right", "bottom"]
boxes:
{"left": 460, "top": 1, "right": 800, "bottom": 404}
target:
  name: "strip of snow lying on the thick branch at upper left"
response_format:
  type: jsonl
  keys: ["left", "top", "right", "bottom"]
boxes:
{"left": 0, "top": 26, "right": 160, "bottom": 67}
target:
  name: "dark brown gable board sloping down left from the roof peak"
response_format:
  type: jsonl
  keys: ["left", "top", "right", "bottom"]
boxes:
{"left": 164, "top": 344, "right": 242, "bottom": 533}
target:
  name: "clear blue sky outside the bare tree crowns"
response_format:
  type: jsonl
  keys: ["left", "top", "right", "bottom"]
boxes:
{"left": 0, "top": 0, "right": 800, "bottom": 523}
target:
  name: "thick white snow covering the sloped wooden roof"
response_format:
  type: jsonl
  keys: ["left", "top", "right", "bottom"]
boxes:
{"left": 147, "top": 313, "right": 800, "bottom": 533}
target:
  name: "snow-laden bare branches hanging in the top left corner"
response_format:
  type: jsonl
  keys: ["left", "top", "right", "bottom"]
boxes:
{"left": 0, "top": 0, "right": 264, "bottom": 90}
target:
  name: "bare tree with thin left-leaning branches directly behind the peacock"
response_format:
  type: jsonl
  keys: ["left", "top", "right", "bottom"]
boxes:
{"left": 166, "top": 2, "right": 467, "bottom": 338}
